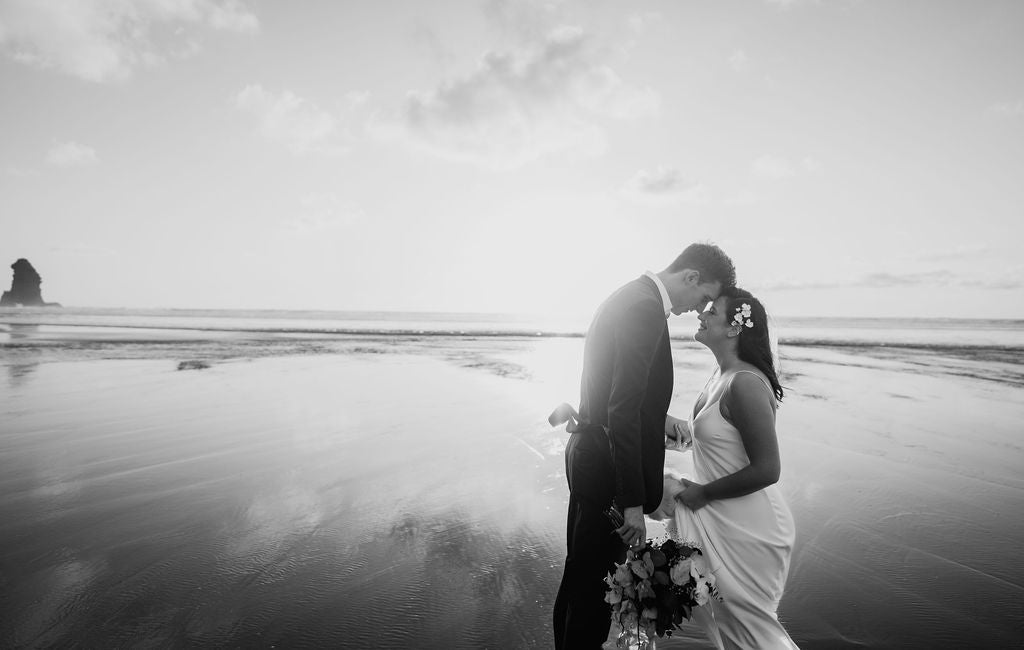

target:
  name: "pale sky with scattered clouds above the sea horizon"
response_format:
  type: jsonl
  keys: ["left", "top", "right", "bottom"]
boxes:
{"left": 0, "top": 0, "right": 1024, "bottom": 318}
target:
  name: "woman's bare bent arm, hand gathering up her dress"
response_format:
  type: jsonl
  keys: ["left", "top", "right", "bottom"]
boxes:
{"left": 679, "top": 373, "right": 781, "bottom": 510}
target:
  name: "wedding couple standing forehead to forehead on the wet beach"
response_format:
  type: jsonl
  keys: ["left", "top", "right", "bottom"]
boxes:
{"left": 552, "top": 244, "right": 797, "bottom": 650}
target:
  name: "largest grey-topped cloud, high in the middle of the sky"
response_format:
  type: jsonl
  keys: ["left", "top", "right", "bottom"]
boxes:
{"left": 377, "top": 28, "right": 659, "bottom": 169}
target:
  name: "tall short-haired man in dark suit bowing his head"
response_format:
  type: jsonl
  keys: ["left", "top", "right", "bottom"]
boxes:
{"left": 554, "top": 244, "right": 736, "bottom": 650}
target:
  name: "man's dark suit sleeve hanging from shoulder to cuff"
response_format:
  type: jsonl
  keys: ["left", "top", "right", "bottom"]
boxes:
{"left": 608, "top": 303, "right": 665, "bottom": 510}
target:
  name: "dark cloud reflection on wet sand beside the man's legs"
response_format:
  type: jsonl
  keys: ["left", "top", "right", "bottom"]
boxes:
{"left": 337, "top": 510, "right": 557, "bottom": 648}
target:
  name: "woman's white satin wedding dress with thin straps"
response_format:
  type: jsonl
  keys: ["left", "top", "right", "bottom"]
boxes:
{"left": 659, "top": 378, "right": 797, "bottom": 650}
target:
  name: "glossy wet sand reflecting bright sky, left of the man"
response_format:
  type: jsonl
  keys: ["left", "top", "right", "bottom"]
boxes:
{"left": 0, "top": 356, "right": 563, "bottom": 647}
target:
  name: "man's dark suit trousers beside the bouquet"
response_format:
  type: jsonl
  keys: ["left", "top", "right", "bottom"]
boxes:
{"left": 554, "top": 492, "right": 626, "bottom": 650}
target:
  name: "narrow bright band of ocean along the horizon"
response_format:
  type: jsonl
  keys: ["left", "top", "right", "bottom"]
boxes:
{"left": 0, "top": 308, "right": 1024, "bottom": 350}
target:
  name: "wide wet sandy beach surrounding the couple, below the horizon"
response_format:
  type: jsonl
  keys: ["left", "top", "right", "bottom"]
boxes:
{"left": 0, "top": 323, "right": 1024, "bottom": 648}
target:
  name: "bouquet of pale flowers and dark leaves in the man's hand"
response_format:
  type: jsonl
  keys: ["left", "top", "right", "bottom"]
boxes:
{"left": 604, "top": 539, "right": 722, "bottom": 649}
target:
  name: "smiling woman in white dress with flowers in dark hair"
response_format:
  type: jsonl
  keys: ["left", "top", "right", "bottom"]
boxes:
{"left": 667, "top": 289, "right": 797, "bottom": 650}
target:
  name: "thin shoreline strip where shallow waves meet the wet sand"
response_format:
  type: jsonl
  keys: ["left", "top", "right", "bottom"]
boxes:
{"left": 8, "top": 326, "right": 1024, "bottom": 387}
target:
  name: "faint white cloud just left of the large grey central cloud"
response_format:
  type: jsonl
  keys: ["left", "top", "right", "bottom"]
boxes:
{"left": 234, "top": 84, "right": 346, "bottom": 154}
